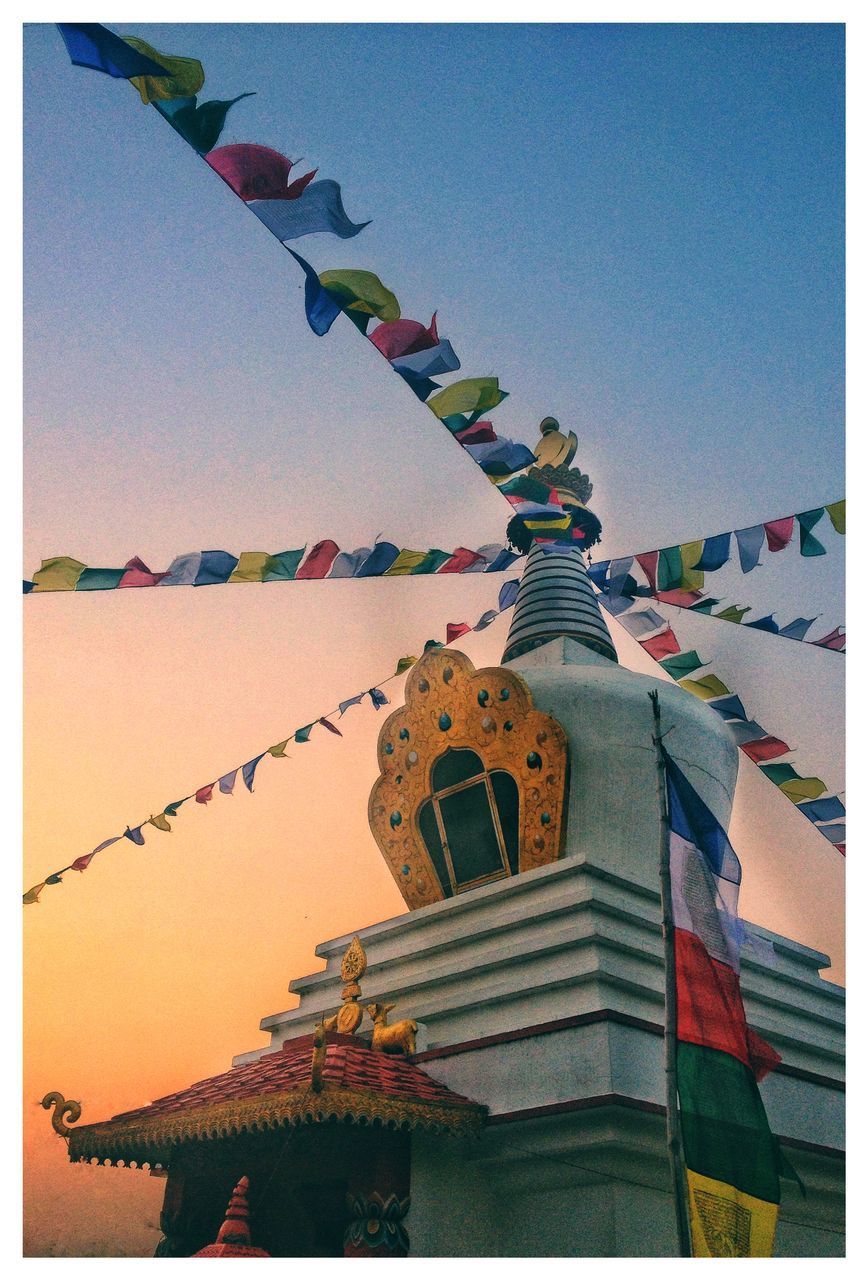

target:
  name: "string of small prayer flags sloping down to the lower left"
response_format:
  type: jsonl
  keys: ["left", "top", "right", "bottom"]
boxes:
{"left": 23, "top": 580, "right": 518, "bottom": 905}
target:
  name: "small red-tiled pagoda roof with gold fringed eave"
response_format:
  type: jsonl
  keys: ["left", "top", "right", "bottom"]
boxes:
{"left": 69, "top": 1032, "right": 486, "bottom": 1166}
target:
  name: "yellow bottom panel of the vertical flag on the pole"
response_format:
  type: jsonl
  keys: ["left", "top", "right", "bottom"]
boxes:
{"left": 686, "top": 1169, "right": 778, "bottom": 1258}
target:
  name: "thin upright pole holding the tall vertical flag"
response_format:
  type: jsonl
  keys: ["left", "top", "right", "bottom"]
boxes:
{"left": 648, "top": 690, "right": 691, "bottom": 1258}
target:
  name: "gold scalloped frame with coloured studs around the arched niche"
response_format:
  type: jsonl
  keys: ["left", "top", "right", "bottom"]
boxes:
{"left": 367, "top": 649, "right": 568, "bottom": 909}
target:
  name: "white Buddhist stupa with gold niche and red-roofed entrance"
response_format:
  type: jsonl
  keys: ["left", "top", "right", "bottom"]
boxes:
{"left": 45, "top": 420, "right": 844, "bottom": 1257}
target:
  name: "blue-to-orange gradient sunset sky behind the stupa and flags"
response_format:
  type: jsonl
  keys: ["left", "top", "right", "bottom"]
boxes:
{"left": 22, "top": 23, "right": 845, "bottom": 1254}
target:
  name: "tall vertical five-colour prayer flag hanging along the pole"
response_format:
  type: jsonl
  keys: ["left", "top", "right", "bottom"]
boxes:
{"left": 663, "top": 753, "right": 784, "bottom": 1257}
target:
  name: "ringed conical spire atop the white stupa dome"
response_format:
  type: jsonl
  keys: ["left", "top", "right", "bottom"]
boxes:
{"left": 503, "top": 544, "right": 618, "bottom": 662}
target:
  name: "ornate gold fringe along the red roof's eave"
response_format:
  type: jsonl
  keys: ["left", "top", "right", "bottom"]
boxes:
{"left": 69, "top": 1084, "right": 486, "bottom": 1166}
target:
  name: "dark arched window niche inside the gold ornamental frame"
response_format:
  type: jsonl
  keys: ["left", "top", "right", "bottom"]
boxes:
{"left": 419, "top": 749, "right": 518, "bottom": 897}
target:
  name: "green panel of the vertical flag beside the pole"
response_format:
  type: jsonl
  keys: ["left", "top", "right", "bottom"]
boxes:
{"left": 677, "top": 1042, "right": 781, "bottom": 1204}
